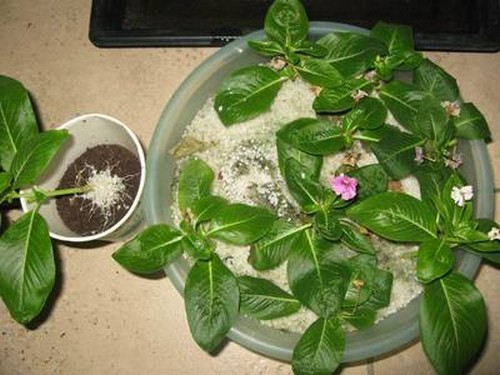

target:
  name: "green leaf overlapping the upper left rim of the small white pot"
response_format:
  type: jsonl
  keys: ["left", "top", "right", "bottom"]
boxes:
{"left": 10, "top": 130, "right": 68, "bottom": 187}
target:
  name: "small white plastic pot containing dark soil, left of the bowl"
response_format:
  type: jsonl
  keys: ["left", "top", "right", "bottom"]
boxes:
{"left": 21, "top": 113, "right": 146, "bottom": 242}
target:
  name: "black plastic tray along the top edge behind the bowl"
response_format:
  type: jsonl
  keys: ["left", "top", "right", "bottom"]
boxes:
{"left": 89, "top": 0, "right": 500, "bottom": 52}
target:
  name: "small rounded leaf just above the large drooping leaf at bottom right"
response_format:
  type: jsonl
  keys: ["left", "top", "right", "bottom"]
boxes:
{"left": 417, "top": 238, "right": 455, "bottom": 284}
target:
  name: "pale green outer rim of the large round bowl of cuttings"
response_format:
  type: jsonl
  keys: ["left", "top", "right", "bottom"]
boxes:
{"left": 145, "top": 21, "right": 494, "bottom": 363}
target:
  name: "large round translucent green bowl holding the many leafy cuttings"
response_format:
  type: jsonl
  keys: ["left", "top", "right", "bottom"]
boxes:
{"left": 144, "top": 22, "right": 493, "bottom": 362}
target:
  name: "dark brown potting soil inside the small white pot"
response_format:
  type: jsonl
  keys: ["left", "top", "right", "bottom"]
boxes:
{"left": 56, "top": 144, "right": 141, "bottom": 236}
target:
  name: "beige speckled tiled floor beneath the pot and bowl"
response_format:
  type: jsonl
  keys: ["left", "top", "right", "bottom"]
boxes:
{"left": 0, "top": 0, "right": 500, "bottom": 375}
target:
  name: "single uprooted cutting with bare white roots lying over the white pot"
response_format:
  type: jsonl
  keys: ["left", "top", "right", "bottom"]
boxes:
{"left": 0, "top": 76, "right": 142, "bottom": 324}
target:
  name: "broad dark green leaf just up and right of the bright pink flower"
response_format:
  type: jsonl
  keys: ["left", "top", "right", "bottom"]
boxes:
{"left": 370, "top": 125, "right": 422, "bottom": 180}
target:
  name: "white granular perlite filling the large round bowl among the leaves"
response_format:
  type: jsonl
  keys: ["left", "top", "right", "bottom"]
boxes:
{"left": 172, "top": 79, "right": 421, "bottom": 332}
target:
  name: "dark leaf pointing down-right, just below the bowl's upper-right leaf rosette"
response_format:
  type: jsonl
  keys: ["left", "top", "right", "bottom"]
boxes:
{"left": 380, "top": 80, "right": 429, "bottom": 132}
